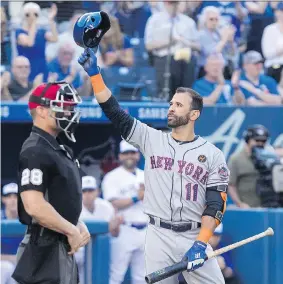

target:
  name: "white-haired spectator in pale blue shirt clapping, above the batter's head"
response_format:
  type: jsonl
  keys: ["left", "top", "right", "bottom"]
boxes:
{"left": 198, "top": 6, "right": 239, "bottom": 79}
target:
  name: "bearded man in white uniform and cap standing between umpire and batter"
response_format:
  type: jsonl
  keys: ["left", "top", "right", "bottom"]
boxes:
{"left": 102, "top": 140, "right": 148, "bottom": 284}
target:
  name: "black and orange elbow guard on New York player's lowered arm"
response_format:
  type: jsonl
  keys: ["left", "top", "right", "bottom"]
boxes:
{"left": 202, "top": 184, "right": 228, "bottom": 224}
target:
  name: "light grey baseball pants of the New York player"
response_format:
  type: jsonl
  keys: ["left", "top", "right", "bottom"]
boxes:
{"left": 145, "top": 224, "right": 225, "bottom": 284}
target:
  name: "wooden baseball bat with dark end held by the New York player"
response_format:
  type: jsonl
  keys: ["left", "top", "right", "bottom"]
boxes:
{"left": 145, "top": 227, "right": 274, "bottom": 284}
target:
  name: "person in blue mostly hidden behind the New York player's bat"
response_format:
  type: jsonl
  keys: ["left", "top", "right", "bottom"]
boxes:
{"left": 209, "top": 223, "right": 240, "bottom": 284}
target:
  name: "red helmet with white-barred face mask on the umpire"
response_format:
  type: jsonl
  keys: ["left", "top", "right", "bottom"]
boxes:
{"left": 28, "top": 82, "right": 82, "bottom": 142}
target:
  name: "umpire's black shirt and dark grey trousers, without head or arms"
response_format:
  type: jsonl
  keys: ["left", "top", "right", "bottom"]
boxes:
{"left": 12, "top": 81, "right": 82, "bottom": 284}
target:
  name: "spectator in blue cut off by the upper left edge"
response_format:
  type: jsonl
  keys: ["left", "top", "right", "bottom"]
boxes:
{"left": 1, "top": 7, "right": 11, "bottom": 69}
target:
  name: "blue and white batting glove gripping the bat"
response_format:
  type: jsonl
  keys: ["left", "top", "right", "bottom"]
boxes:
{"left": 183, "top": 241, "right": 207, "bottom": 271}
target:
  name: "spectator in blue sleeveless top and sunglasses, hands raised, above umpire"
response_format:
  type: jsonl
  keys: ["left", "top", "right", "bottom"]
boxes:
{"left": 16, "top": 2, "right": 58, "bottom": 81}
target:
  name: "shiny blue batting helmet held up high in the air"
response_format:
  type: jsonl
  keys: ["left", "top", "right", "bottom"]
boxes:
{"left": 73, "top": 11, "right": 110, "bottom": 51}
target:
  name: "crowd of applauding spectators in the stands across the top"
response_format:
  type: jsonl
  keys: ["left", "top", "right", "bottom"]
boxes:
{"left": 1, "top": 1, "right": 283, "bottom": 106}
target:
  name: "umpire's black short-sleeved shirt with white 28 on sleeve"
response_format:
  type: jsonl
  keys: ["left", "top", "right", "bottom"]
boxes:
{"left": 18, "top": 126, "right": 82, "bottom": 225}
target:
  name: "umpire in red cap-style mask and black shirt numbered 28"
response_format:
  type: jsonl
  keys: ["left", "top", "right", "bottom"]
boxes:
{"left": 12, "top": 82, "right": 90, "bottom": 284}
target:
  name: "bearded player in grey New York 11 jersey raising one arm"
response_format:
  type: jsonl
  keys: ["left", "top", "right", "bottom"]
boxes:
{"left": 78, "top": 48, "right": 229, "bottom": 284}
